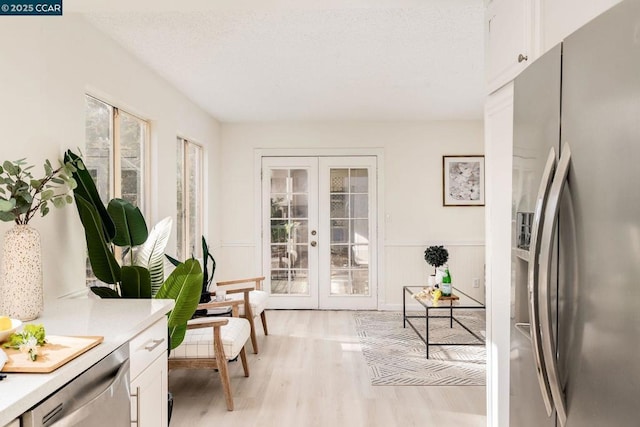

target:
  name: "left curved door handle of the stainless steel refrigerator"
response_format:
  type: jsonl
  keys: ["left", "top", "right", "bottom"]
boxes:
{"left": 527, "top": 147, "right": 556, "bottom": 416}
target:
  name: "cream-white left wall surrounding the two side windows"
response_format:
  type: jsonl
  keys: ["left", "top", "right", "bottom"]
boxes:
{"left": 0, "top": 13, "right": 219, "bottom": 307}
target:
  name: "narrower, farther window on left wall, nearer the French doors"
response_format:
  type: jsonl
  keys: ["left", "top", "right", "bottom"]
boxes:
{"left": 176, "top": 137, "right": 203, "bottom": 259}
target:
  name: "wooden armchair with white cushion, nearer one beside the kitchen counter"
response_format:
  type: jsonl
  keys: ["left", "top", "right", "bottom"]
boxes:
{"left": 169, "top": 301, "right": 251, "bottom": 411}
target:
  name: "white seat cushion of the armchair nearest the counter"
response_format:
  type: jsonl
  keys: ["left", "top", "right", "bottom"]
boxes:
{"left": 169, "top": 317, "right": 251, "bottom": 359}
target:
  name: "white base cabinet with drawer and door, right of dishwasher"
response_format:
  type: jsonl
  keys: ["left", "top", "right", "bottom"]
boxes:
{"left": 129, "top": 317, "right": 168, "bottom": 427}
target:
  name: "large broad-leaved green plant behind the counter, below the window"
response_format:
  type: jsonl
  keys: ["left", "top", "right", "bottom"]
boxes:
{"left": 66, "top": 151, "right": 203, "bottom": 349}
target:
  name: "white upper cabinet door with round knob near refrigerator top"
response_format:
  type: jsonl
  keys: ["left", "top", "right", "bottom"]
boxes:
{"left": 485, "top": 0, "right": 537, "bottom": 93}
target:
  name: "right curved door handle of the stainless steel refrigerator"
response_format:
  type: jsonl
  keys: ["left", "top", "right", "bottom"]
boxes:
{"left": 538, "top": 143, "right": 571, "bottom": 426}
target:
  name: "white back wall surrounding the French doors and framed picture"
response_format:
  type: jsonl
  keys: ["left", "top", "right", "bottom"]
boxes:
{"left": 216, "top": 121, "right": 484, "bottom": 309}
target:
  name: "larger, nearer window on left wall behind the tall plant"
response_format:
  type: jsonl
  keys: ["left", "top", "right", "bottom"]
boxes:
{"left": 83, "top": 95, "right": 149, "bottom": 283}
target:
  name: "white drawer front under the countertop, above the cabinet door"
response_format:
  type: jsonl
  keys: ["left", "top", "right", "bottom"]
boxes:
{"left": 129, "top": 316, "right": 168, "bottom": 380}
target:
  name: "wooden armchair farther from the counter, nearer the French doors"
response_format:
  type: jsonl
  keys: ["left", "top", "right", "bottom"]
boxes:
{"left": 212, "top": 276, "right": 269, "bottom": 354}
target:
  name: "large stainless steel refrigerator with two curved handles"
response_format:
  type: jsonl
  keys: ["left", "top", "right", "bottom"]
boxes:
{"left": 510, "top": 0, "right": 640, "bottom": 427}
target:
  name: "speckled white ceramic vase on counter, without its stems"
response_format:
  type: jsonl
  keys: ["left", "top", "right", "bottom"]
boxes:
{"left": 0, "top": 225, "right": 44, "bottom": 321}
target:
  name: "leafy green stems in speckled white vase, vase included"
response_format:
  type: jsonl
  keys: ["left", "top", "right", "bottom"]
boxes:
{"left": 0, "top": 155, "right": 82, "bottom": 320}
